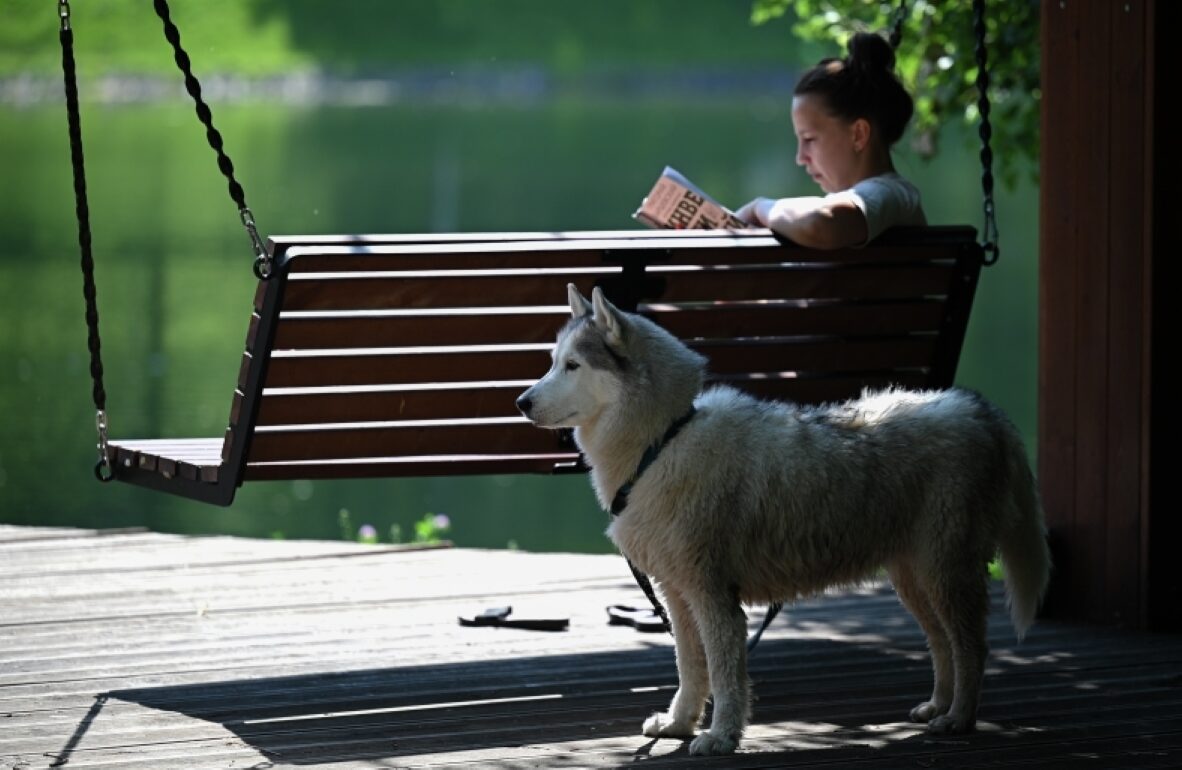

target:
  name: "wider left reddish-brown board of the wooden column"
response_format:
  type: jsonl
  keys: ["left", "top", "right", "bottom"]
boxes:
{"left": 1038, "top": 4, "right": 1112, "bottom": 622}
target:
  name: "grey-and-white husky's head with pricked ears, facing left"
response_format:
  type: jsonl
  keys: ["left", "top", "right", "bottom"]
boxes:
{"left": 517, "top": 284, "right": 629, "bottom": 428}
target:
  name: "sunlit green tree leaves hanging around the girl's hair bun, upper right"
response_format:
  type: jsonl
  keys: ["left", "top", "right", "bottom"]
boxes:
{"left": 752, "top": 0, "right": 1041, "bottom": 187}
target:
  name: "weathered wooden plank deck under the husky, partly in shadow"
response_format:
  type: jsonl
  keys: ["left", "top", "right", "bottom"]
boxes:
{"left": 0, "top": 526, "right": 1182, "bottom": 770}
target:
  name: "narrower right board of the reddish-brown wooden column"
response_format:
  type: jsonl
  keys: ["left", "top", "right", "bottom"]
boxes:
{"left": 1090, "top": 4, "right": 1148, "bottom": 628}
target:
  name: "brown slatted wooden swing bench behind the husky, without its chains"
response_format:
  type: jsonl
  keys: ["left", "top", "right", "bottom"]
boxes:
{"left": 109, "top": 226, "right": 982, "bottom": 505}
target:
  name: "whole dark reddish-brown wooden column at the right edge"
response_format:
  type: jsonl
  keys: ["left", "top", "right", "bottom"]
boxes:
{"left": 1040, "top": 0, "right": 1178, "bottom": 628}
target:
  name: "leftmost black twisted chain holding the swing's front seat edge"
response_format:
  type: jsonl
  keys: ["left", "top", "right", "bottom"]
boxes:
{"left": 58, "top": 0, "right": 113, "bottom": 481}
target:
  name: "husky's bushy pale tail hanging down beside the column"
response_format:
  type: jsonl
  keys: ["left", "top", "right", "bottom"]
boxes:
{"left": 998, "top": 448, "right": 1051, "bottom": 641}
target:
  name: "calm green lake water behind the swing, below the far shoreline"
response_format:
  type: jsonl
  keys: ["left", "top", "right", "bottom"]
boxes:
{"left": 0, "top": 96, "right": 1038, "bottom": 551}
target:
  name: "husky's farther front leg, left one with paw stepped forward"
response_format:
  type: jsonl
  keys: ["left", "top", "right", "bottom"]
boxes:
{"left": 643, "top": 590, "right": 710, "bottom": 738}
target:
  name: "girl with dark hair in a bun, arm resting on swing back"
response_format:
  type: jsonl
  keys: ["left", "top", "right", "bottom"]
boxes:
{"left": 735, "top": 32, "right": 927, "bottom": 248}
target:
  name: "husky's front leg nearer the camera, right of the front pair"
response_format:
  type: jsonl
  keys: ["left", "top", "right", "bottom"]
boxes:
{"left": 689, "top": 590, "right": 751, "bottom": 755}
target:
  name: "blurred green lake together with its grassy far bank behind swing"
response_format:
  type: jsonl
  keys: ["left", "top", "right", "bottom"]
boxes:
{"left": 0, "top": 0, "right": 1038, "bottom": 552}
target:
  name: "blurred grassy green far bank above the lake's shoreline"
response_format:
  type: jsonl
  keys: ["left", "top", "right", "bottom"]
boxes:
{"left": 0, "top": 0, "right": 797, "bottom": 77}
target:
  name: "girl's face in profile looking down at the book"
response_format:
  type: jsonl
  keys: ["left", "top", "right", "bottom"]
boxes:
{"left": 792, "top": 93, "right": 869, "bottom": 193}
